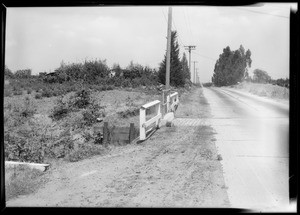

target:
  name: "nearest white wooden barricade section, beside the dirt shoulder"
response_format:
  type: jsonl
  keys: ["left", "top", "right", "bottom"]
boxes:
{"left": 140, "top": 100, "right": 162, "bottom": 140}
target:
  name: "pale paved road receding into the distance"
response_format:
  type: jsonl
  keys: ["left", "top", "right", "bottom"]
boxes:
{"left": 203, "top": 88, "right": 289, "bottom": 211}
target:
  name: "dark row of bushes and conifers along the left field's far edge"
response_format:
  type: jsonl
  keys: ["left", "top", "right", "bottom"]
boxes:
{"left": 5, "top": 31, "right": 191, "bottom": 87}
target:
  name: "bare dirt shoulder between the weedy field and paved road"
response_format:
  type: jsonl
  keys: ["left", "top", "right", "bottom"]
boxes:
{"left": 7, "top": 86, "right": 229, "bottom": 207}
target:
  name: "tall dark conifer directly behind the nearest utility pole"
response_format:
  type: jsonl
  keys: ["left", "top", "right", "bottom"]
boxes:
{"left": 158, "top": 31, "right": 185, "bottom": 86}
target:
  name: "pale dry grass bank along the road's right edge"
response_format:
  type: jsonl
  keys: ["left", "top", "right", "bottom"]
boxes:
{"left": 234, "top": 82, "right": 290, "bottom": 100}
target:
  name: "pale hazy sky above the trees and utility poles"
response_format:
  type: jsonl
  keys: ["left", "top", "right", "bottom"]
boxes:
{"left": 5, "top": 3, "right": 297, "bottom": 82}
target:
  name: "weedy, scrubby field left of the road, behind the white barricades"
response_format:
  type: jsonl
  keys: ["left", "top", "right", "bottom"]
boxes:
{"left": 4, "top": 80, "right": 192, "bottom": 198}
